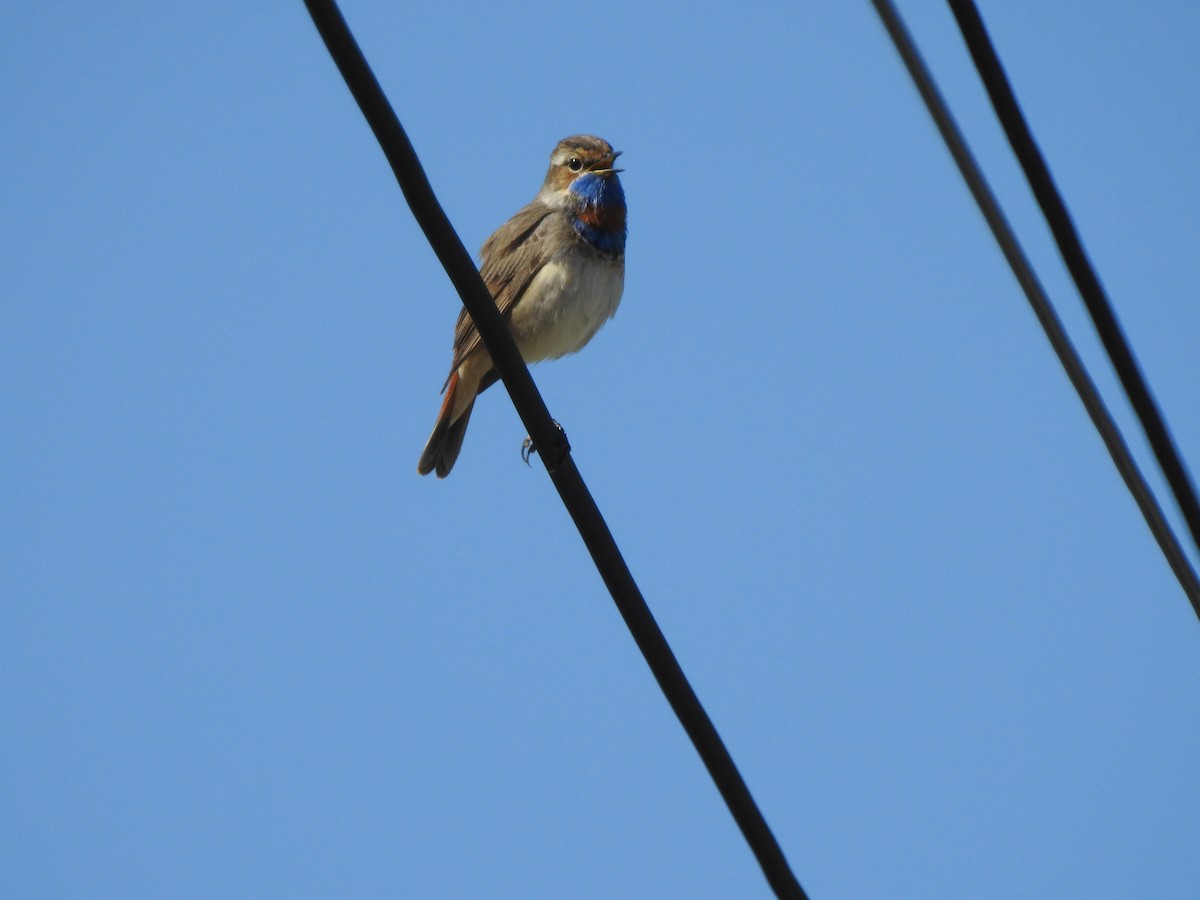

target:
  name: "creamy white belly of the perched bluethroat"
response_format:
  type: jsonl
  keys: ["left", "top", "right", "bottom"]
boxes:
{"left": 511, "top": 252, "right": 625, "bottom": 362}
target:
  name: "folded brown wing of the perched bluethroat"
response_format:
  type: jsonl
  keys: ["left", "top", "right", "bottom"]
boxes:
{"left": 450, "top": 200, "right": 561, "bottom": 374}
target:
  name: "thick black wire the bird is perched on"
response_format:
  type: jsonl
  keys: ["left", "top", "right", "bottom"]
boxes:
{"left": 305, "top": 0, "right": 808, "bottom": 899}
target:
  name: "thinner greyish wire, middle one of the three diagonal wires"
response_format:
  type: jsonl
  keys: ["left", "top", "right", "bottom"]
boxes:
{"left": 871, "top": 0, "right": 1200, "bottom": 618}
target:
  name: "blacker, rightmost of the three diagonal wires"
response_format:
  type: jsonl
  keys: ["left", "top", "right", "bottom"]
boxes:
{"left": 948, "top": 0, "right": 1200, "bottom": 561}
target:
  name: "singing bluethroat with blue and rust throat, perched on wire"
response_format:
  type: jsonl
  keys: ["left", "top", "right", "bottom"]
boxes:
{"left": 416, "top": 134, "right": 625, "bottom": 478}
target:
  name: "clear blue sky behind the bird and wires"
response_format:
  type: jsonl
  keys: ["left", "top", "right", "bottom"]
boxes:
{"left": 0, "top": 0, "right": 1200, "bottom": 900}
